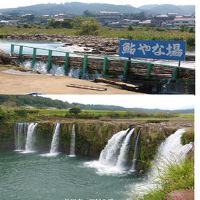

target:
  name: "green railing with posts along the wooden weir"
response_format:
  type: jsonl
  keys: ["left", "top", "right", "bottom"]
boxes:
{"left": 11, "top": 44, "right": 183, "bottom": 80}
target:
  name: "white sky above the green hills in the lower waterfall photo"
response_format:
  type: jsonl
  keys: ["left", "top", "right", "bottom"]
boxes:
{"left": 42, "top": 95, "right": 195, "bottom": 110}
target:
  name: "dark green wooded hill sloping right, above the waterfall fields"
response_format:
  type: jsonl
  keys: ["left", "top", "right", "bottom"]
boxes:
{"left": 0, "top": 95, "right": 194, "bottom": 113}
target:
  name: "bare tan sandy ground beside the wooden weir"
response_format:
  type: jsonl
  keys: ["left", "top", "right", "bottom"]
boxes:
{"left": 0, "top": 68, "right": 138, "bottom": 94}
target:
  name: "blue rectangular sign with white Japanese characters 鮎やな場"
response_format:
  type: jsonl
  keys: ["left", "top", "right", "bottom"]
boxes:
{"left": 119, "top": 40, "right": 186, "bottom": 60}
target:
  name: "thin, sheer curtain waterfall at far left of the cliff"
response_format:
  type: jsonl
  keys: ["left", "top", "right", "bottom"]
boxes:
{"left": 14, "top": 123, "right": 28, "bottom": 151}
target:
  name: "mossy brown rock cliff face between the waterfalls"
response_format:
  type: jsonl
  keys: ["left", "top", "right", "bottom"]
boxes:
{"left": 0, "top": 120, "right": 193, "bottom": 170}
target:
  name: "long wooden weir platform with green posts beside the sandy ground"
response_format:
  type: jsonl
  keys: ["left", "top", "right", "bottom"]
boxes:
{"left": 11, "top": 44, "right": 195, "bottom": 93}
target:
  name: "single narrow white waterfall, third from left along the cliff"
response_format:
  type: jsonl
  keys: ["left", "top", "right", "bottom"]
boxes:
{"left": 49, "top": 123, "right": 60, "bottom": 155}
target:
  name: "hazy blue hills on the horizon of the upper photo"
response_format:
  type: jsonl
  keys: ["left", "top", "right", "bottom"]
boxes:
{"left": 0, "top": 2, "right": 195, "bottom": 16}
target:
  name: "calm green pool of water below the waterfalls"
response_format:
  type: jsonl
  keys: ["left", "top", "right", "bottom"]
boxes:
{"left": 0, "top": 152, "right": 141, "bottom": 200}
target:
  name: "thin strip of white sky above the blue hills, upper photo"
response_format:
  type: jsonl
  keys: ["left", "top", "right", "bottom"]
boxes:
{"left": 0, "top": 0, "right": 195, "bottom": 8}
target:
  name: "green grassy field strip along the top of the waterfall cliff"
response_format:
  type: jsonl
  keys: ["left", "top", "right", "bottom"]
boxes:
{"left": 0, "top": 102, "right": 194, "bottom": 122}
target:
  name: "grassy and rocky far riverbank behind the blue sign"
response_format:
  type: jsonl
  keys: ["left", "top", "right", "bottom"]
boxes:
{"left": 0, "top": 27, "right": 195, "bottom": 55}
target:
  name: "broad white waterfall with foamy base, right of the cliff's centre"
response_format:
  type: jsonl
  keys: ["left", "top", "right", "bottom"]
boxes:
{"left": 85, "top": 129, "right": 134, "bottom": 175}
